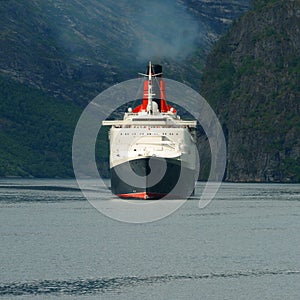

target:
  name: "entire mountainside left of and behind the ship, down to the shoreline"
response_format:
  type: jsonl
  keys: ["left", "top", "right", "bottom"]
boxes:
{"left": 0, "top": 0, "right": 249, "bottom": 177}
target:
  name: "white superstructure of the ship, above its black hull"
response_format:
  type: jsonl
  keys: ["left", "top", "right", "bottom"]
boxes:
{"left": 103, "top": 112, "right": 197, "bottom": 169}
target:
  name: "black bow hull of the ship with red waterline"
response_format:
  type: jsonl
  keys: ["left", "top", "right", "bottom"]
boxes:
{"left": 111, "top": 158, "right": 196, "bottom": 199}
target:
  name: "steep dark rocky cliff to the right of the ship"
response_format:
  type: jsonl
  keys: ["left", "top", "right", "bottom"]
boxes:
{"left": 202, "top": 0, "right": 300, "bottom": 182}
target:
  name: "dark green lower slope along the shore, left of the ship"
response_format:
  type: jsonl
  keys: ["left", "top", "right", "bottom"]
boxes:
{"left": 0, "top": 77, "right": 80, "bottom": 177}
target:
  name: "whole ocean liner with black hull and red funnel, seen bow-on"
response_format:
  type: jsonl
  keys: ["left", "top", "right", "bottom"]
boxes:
{"left": 102, "top": 62, "right": 198, "bottom": 199}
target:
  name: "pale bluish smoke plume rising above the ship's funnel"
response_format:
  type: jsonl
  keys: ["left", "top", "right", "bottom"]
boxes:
{"left": 135, "top": 0, "right": 201, "bottom": 60}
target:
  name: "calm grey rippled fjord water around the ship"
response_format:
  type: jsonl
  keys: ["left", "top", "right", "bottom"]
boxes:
{"left": 0, "top": 180, "right": 300, "bottom": 300}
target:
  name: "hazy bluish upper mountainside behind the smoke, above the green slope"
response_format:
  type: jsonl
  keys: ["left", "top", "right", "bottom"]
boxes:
{"left": 0, "top": 0, "right": 249, "bottom": 104}
